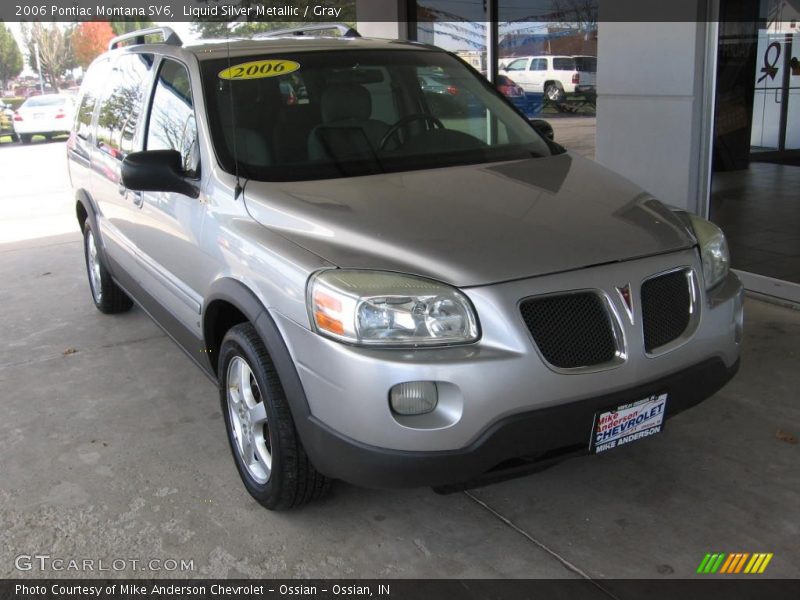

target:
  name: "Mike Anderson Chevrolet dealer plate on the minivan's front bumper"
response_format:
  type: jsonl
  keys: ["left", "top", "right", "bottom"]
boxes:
{"left": 589, "top": 394, "right": 667, "bottom": 454}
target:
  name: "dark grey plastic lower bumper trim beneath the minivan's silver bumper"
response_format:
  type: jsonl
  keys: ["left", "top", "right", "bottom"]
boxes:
{"left": 303, "top": 358, "right": 739, "bottom": 488}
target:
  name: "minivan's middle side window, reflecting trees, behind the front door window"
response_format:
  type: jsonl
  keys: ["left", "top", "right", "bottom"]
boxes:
{"left": 96, "top": 54, "right": 153, "bottom": 160}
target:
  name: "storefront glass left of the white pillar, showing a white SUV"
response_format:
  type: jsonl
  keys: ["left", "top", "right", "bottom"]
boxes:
{"left": 411, "top": 0, "right": 599, "bottom": 158}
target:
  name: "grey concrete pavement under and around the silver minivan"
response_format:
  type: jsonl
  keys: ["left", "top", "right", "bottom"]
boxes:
{"left": 0, "top": 141, "right": 800, "bottom": 578}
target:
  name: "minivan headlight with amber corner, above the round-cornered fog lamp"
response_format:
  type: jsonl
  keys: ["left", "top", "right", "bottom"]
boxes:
{"left": 308, "top": 269, "right": 478, "bottom": 346}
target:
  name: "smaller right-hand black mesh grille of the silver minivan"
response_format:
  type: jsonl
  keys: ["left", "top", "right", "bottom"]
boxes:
{"left": 642, "top": 270, "right": 692, "bottom": 353}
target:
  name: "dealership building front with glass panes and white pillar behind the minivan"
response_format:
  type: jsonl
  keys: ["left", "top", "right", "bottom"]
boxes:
{"left": 356, "top": 0, "right": 800, "bottom": 302}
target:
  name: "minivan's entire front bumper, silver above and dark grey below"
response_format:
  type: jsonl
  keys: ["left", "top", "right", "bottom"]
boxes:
{"left": 273, "top": 248, "right": 742, "bottom": 485}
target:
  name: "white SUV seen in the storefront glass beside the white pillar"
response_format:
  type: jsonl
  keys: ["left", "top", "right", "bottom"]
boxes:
{"left": 500, "top": 56, "right": 597, "bottom": 102}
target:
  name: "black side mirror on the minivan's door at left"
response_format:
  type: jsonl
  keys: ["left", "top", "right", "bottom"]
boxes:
{"left": 121, "top": 150, "right": 200, "bottom": 198}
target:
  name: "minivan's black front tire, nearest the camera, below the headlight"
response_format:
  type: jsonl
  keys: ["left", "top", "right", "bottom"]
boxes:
{"left": 218, "top": 323, "right": 331, "bottom": 510}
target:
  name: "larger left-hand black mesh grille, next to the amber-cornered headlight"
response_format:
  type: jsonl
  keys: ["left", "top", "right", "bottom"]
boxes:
{"left": 520, "top": 292, "right": 617, "bottom": 369}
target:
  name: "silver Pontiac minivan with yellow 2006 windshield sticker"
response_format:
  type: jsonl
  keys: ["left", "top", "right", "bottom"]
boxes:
{"left": 67, "top": 29, "right": 742, "bottom": 509}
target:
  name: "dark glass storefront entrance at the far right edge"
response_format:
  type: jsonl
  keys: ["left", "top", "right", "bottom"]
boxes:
{"left": 710, "top": 0, "right": 800, "bottom": 294}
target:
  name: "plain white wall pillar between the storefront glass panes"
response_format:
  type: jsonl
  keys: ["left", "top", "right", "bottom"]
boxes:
{"left": 595, "top": 22, "right": 715, "bottom": 212}
